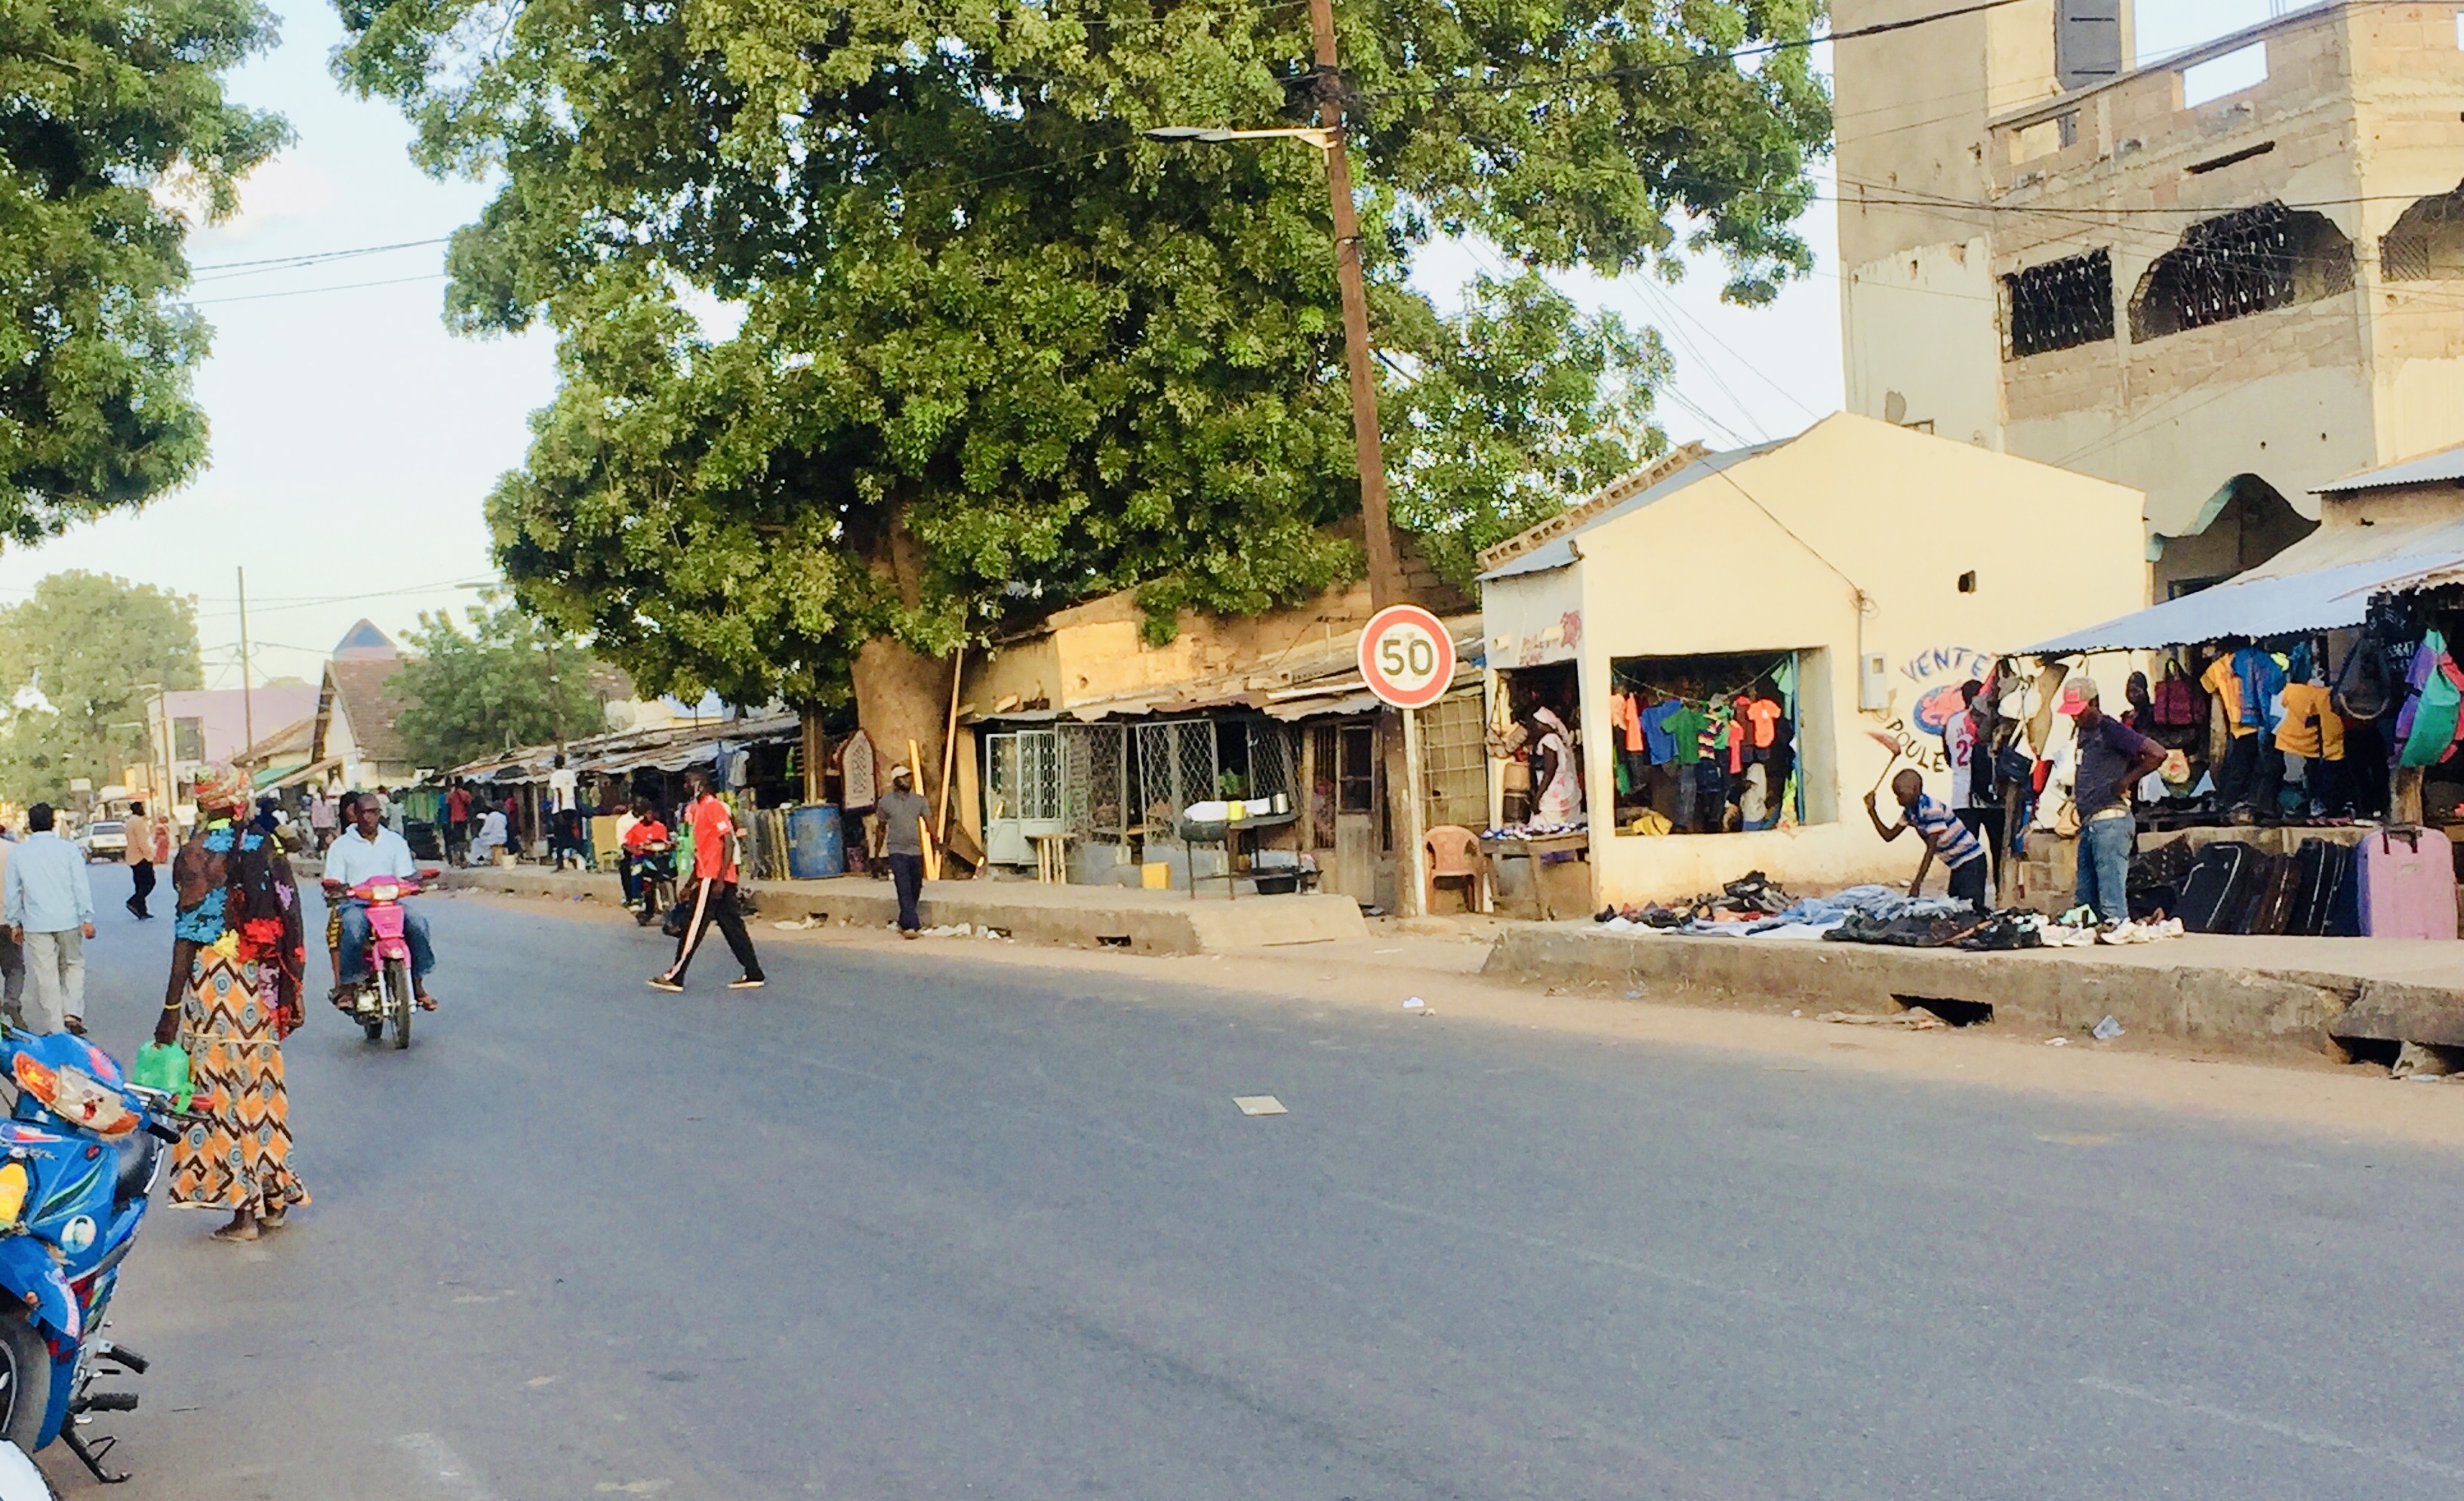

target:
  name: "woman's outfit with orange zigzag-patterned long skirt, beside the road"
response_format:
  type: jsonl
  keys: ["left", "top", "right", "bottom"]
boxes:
{"left": 170, "top": 823, "right": 308, "bottom": 1213}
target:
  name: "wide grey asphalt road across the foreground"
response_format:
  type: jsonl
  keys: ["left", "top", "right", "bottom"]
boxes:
{"left": 33, "top": 873, "right": 2464, "bottom": 1501}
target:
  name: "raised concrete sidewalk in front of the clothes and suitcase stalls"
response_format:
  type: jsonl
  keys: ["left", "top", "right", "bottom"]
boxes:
{"left": 1483, "top": 922, "right": 2464, "bottom": 1050}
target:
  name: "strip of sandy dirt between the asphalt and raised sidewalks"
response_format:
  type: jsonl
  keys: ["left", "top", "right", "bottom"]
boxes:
{"left": 448, "top": 892, "right": 2464, "bottom": 1148}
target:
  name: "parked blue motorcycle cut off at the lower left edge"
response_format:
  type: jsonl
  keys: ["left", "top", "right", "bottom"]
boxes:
{"left": 0, "top": 1031, "right": 199, "bottom": 1484}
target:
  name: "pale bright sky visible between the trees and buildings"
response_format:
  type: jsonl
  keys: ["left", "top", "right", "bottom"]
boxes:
{"left": 0, "top": 0, "right": 2284, "bottom": 688}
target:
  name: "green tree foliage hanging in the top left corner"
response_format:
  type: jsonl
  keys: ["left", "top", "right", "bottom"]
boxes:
{"left": 0, "top": 0, "right": 283, "bottom": 542}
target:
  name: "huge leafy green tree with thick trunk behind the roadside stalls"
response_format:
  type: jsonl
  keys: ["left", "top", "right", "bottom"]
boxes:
{"left": 337, "top": 0, "right": 1828, "bottom": 744}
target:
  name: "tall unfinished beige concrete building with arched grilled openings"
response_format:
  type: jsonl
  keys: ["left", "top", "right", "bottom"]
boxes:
{"left": 1833, "top": 0, "right": 2464, "bottom": 599}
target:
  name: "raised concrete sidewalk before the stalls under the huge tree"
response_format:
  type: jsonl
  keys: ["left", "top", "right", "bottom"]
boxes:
{"left": 441, "top": 865, "right": 1368, "bottom": 954}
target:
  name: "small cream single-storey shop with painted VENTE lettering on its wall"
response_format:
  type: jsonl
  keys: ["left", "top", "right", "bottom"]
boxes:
{"left": 1481, "top": 414, "right": 2146, "bottom": 907}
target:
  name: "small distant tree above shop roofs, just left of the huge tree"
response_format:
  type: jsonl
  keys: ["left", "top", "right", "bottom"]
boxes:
{"left": 387, "top": 599, "right": 606, "bottom": 766}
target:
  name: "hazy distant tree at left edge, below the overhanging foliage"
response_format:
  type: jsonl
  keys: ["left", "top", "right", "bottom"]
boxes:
{"left": 0, "top": 572, "right": 205, "bottom": 803}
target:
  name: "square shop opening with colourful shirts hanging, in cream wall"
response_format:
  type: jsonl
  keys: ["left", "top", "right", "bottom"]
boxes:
{"left": 1609, "top": 651, "right": 1806, "bottom": 836}
